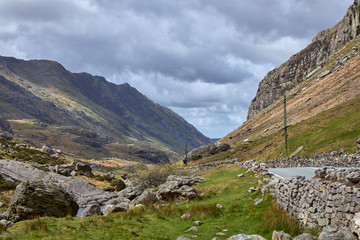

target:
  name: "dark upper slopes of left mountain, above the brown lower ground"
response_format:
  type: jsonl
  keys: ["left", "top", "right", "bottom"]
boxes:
{"left": 0, "top": 57, "right": 211, "bottom": 162}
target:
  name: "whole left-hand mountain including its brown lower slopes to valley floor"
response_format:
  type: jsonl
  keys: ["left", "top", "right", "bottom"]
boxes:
{"left": 0, "top": 57, "right": 211, "bottom": 162}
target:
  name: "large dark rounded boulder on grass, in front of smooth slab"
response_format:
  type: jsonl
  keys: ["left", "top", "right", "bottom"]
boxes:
{"left": 6, "top": 181, "right": 79, "bottom": 222}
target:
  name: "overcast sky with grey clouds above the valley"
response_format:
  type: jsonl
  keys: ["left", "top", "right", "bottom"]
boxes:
{"left": 0, "top": 0, "right": 353, "bottom": 137}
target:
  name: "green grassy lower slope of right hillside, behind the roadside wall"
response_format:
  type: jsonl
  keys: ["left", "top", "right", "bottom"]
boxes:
{"left": 204, "top": 96, "right": 360, "bottom": 163}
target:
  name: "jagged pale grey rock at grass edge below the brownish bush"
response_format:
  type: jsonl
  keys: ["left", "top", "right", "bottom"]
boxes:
{"left": 156, "top": 175, "right": 205, "bottom": 200}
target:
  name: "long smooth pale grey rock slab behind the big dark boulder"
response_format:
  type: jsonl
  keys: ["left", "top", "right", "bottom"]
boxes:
{"left": 0, "top": 160, "right": 117, "bottom": 207}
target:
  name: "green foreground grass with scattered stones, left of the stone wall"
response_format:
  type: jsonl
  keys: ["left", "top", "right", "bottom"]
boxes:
{"left": 0, "top": 166, "right": 310, "bottom": 240}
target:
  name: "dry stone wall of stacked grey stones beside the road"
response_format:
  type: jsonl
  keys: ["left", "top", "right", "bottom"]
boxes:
{"left": 272, "top": 169, "right": 360, "bottom": 228}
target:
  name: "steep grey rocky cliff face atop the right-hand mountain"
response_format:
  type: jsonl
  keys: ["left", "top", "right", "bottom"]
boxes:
{"left": 247, "top": 0, "right": 360, "bottom": 119}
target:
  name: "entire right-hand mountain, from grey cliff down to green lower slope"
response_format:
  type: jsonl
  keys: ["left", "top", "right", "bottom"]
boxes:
{"left": 191, "top": 0, "right": 360, "bottom": 161}
